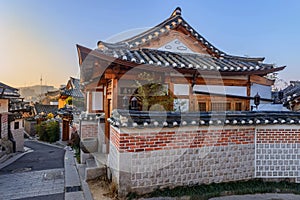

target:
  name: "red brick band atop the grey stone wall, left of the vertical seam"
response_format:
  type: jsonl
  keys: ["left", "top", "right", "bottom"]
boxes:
{"left": 111, "top": 128, "right": 255, "bottom": 153}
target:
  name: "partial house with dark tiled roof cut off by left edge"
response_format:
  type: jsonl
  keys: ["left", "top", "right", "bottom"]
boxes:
{"left": 0, "top": 82, "right": 31, "bottom": 160}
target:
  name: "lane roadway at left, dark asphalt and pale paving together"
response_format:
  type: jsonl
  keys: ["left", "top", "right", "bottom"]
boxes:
{"left": 0, "top": 141, "right": 65, "bottom": 200}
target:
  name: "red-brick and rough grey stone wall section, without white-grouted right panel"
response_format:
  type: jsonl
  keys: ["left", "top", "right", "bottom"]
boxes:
{"left": 108, "top": 126, "right": 255, "bottom": 196}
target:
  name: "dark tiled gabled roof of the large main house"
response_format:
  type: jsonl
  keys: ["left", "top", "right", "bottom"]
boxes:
{"left": 77, "top": 8, "right": 285, "bottom": 75}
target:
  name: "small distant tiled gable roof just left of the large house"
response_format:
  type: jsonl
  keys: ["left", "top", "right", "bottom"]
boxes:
{"left": 60, "top": 77, "right": 84, "bottom": 98}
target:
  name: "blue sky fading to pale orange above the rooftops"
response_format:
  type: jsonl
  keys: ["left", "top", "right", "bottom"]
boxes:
{"left": 0, "top": 0, "right": 300, "bottom": 87}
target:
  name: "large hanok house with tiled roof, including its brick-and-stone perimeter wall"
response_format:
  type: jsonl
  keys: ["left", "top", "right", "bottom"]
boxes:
{"left": 77, "top": 8, "right": 300, "bottom": 196}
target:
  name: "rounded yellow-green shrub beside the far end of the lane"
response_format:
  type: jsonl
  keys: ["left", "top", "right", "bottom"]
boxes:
{"left": 36, "top": 120, "right": 59, "bottom": 143}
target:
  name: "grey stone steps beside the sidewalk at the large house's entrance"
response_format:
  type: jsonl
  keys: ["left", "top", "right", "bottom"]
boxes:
{"left": 85, "top": 158, "right": 106, "bottom": 181}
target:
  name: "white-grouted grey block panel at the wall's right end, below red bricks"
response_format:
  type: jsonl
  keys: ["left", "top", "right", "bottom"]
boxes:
{"left": 255, "top": 143, "right": 300, "bottom": 178}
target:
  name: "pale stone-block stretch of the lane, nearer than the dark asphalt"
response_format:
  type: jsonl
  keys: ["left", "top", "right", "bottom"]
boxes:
{"left": 0, "top": 168, "right": 65, "bottom": 200}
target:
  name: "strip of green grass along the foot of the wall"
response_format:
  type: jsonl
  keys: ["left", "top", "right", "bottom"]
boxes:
{"left": 127, "top": 179, "right": 300, "bottom": 200}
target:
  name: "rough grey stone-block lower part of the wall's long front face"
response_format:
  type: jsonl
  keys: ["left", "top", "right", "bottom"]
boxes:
{"left": 131, "top": 144, "right": 255, "bottom": 189}
